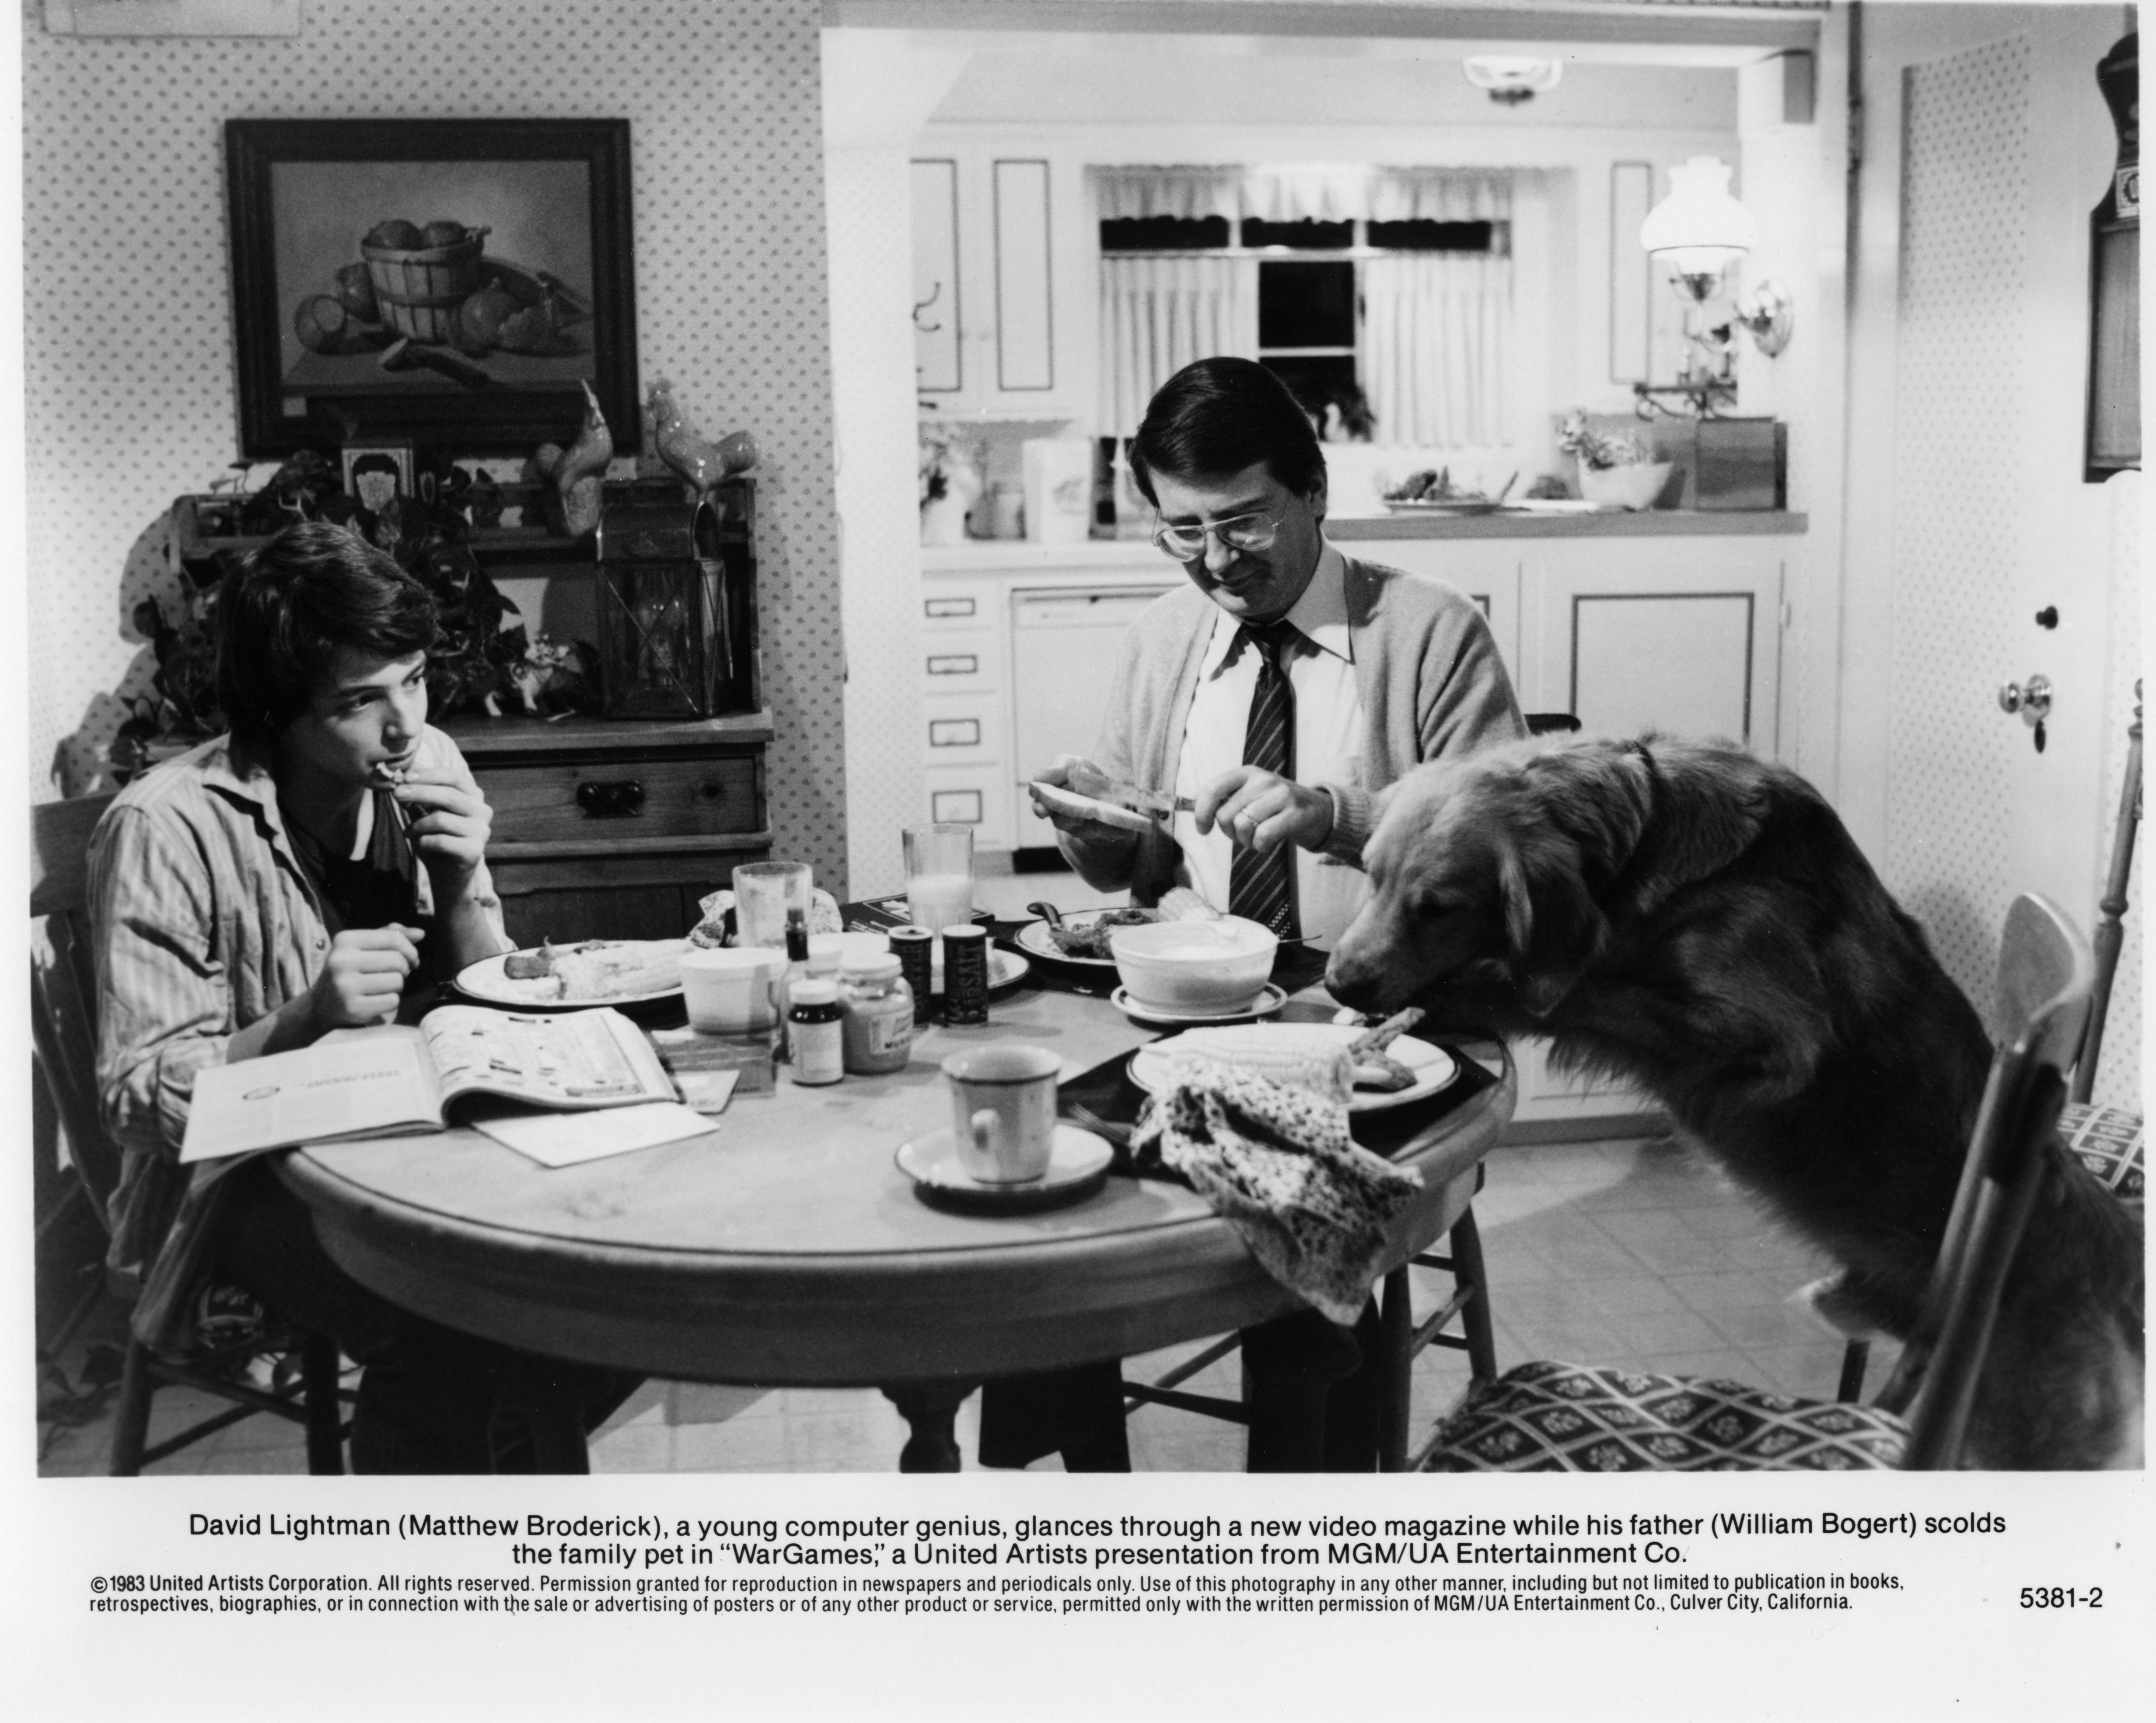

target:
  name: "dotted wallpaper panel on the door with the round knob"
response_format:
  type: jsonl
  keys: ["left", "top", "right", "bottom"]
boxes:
{"left": 1880, "top": 37, "right": 2029, "bottom": 1011}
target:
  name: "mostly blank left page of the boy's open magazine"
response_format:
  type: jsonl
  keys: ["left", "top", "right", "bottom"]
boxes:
{"left": 179, "top": 1026, "right": 442, "bottom": 1162}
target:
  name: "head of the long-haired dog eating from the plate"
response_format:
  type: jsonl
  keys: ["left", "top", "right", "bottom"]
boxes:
{"left": 1326, "top": 742, "right": 1652, "bottom": 1016}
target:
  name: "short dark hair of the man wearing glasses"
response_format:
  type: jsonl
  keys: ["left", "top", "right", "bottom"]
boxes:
{"left": 1130, "top": 358, "right": 1326, "bottom": 507}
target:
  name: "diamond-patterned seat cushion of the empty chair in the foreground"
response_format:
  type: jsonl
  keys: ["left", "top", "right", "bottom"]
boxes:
{"left": 1425, "top": 1361, "right": 1906, "bottom": 1471}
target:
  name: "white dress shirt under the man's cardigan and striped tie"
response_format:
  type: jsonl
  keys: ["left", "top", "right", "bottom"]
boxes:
{"left": 1175, "top": 544, "right": 1369, "bottom": 945}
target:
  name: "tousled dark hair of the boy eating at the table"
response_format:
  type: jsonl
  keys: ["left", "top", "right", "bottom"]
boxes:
{"left": 218, "top": 520, "right": 438, "bottom": 742}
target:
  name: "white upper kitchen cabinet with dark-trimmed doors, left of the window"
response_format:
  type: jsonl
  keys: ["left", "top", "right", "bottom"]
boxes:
{"left": 912, "top": 144, "right": 1093, "bottom": 423}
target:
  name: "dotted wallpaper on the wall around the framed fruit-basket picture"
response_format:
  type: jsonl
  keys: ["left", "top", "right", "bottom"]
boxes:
{"left": 21, "top": 0, "right": 845, "bottom": 889}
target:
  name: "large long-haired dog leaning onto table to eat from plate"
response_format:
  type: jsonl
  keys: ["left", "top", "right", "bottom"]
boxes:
{"left": 1326, "top": 737, "right": 2143, "bottom": 1466}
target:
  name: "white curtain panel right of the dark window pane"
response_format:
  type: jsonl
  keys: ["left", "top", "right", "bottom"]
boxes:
{"left": 1363, "top": 252, "right": 1511, "bottom": 449}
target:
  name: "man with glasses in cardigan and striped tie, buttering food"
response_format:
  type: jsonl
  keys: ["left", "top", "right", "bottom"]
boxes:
{"left": 1035, "top": 358, "right": 1524, "bottom": 942}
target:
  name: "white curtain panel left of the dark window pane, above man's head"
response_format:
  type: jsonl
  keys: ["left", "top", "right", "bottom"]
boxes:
{"left": 1100, "top": 257, "right": 1257, "bottom": 438}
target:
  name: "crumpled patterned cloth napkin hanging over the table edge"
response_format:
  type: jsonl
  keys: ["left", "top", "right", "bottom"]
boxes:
{"left": 1130, "top": 1057, "right": 1423, "bottom": 1326}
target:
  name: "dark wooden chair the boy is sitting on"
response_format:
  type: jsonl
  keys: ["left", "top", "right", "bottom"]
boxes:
{"left": 30, "top": 796, "right": 345, "bottom": 1477}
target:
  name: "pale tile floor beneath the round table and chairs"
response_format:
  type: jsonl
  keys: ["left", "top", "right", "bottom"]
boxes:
{"left": 39, "top": 1141, "right": 1889, "bottom": 1477}
